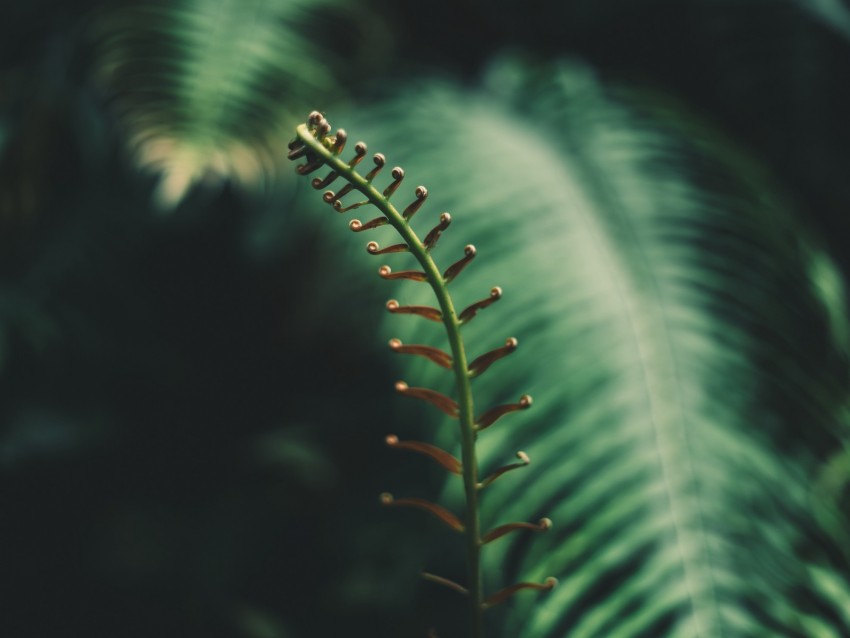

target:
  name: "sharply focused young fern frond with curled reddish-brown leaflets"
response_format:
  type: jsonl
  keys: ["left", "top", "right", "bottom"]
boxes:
{"left": 289, "top": 111, "right": 556, "bottom": 638}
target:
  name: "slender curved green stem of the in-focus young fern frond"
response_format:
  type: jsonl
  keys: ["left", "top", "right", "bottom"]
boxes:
{"left": 297, "top": 124, "right": 484, "bottom": 638}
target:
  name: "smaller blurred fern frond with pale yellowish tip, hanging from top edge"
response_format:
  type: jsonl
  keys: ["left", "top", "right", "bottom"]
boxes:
{"left": 94, "top": 0, "right": 339, "bottom": 208}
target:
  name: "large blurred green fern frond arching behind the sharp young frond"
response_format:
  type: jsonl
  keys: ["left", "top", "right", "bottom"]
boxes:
{"left": 328, "top": 57, "right": 850, "bottom": 638}
